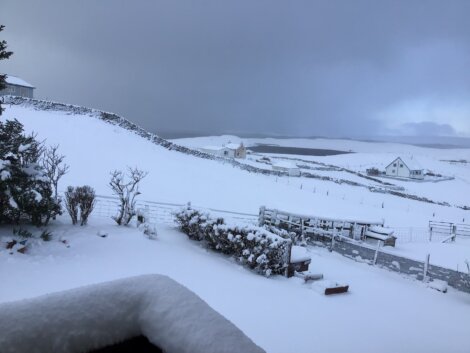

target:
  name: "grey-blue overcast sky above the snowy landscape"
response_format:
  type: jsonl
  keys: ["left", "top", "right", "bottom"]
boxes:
{"left": 0, "top": 0, "right": 470, "bottom": 137}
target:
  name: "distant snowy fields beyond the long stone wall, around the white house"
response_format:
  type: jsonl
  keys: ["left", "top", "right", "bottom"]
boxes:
{"left": 172, "top": 135, "right": 470, "bottom": 206}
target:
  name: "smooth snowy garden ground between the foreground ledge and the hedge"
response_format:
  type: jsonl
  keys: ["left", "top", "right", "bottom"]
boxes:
{"left": 0, "top": 219, "right": 470, "bottom": 353}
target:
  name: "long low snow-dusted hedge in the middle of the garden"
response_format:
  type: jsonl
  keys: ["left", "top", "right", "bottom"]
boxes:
{"left": 175, "top": 205, "right": 291, "bottom": 276}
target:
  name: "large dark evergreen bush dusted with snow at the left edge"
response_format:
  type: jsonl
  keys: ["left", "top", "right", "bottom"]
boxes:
{"left": 0, "top": 120, "right": 61, "bottom": 226}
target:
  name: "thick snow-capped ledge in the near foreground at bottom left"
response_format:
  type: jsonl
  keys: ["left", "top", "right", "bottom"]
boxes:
{"left": 0, "top": 275, "right": 264, "bottom": 353}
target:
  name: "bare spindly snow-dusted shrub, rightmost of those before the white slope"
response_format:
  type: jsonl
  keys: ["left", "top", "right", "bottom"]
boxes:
{"left": 109, "top": 168, "right": 147, "bottom": 225}
